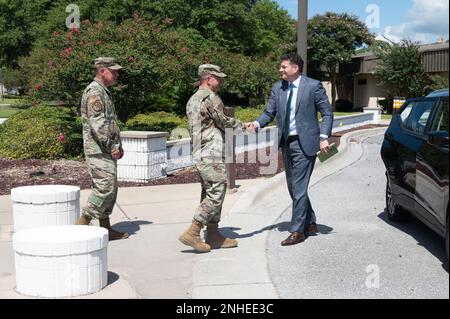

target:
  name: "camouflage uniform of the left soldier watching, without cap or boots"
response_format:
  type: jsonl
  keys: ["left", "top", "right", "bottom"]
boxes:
{"left": 81, "top": 80, "right": 122, "bottom": 219}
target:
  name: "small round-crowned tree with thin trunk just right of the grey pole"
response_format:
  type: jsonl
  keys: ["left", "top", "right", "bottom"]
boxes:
{"left": 308, "top": 12, "right": 374, "bottom": 108}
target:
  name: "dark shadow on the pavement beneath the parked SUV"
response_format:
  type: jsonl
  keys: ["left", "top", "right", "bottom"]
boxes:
{"left": 378, "top": 209, "right": 448, "bottom": 272}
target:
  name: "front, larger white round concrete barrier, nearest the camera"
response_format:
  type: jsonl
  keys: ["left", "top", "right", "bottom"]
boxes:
{"left": 13, "top": 225, "right": 108, "bottom": 298}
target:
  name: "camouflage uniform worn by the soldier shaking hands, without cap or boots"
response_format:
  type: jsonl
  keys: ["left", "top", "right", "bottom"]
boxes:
{"left": 186, "top": 87, "right": 245, "bottom": 225}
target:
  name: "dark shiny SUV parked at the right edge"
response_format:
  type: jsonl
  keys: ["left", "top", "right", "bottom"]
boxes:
{"left": 381, "top": 90, "right": 449, "bottom": 260}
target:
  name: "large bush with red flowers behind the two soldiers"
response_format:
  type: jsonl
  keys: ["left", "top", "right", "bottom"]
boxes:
{"left": 20, "top": 15, "right": 278, "bottom": 121}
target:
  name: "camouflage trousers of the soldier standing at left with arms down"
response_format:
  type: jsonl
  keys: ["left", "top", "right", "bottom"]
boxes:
{"left": 82, "top": 154, "right": 117, "bottom": 219}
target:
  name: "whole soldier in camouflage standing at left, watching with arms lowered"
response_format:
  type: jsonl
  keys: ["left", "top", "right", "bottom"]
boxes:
{"left": 77, "top": 57, "right": 128, "bottom": 240}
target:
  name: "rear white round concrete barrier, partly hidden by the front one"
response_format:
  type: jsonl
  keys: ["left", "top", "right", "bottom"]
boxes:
{"left": 11, "top": 185, "right": 80, "bottom": 231}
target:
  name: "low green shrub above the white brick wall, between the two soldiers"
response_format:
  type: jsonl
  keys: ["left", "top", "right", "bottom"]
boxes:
{"left": 125, "top": 112, "right": 188, "bottom": 133}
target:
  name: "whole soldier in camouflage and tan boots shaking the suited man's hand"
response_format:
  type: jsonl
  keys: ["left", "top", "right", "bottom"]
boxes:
{"left": 179, "top": 64, "right": 250, "bottom": 252}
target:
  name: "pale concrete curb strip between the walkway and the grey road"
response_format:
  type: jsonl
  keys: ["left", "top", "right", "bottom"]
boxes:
{"left": 189, "top": 127, "right": 387, "bottom": 299}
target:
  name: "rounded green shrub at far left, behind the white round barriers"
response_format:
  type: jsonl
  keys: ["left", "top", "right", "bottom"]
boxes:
{"left": 0, "top": 105, "right": 83, "bottom": 159}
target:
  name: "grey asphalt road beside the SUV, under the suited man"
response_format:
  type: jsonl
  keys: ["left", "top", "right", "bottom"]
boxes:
{"left": 266, "top": 134, "right": 449, "bottom": 299}
